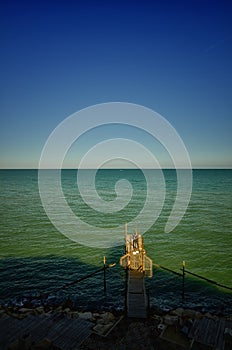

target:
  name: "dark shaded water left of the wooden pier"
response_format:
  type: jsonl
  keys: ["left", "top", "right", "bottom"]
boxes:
{"left": 0, "top": 248, "right": 124, "bottom": 309}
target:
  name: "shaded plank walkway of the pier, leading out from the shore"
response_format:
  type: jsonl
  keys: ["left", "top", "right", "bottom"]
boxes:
{"left": 127, "top": 270, "right": 147, "bottom": 318}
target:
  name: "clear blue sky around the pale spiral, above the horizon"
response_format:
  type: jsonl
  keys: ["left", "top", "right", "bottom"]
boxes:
{"left": 0, "top": 0, "right": 232, "bottom": 168}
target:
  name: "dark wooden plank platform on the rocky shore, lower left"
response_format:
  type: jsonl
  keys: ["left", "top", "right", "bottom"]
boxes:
{"left": 0, "top": 315, "right": 93, "bottom": 350}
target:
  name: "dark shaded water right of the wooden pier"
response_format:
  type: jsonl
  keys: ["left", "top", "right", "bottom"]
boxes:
{"left": 146, "top": 268, "right": 232, "bottom": 314}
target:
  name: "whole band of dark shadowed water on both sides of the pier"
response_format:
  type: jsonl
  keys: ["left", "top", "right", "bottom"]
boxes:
{"left": 0, "top": 247, "right": 232, "bottom": 314}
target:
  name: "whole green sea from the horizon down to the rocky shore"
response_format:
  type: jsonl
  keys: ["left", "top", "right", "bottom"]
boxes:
{"left": 0, "top": 169, "right": 232, "bottom": 314}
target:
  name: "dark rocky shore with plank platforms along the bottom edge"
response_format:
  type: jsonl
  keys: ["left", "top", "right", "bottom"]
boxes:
{"left": 0, "top": 301, "right": 232, "bottom": 350}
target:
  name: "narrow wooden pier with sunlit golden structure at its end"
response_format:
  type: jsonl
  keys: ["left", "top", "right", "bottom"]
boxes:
{"left": 120, "top": 225, "right": 152, "bottom": 318}
